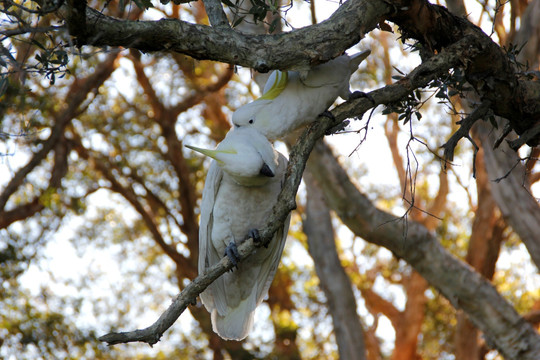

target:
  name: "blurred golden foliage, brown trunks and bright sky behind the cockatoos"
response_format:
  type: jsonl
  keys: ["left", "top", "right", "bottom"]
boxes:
{"left": 0, "top": 0, "right": 540, "bottom": 360}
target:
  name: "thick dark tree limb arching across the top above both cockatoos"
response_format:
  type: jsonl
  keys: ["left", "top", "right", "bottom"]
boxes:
{"left": 58, "top": 0, "right": 540, "bottom": 146}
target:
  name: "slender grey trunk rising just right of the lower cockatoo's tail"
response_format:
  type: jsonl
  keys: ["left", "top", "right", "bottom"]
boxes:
{"left": 303, "top": 167, "right": 366, "bottom": 360}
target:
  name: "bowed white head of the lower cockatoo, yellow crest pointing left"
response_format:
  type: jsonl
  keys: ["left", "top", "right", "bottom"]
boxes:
{"left": 186, "top": 127, "right": 278, "bottom": 186}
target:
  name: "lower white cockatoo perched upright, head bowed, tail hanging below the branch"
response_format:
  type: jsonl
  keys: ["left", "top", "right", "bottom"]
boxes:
{"left": 189, "top": 127, "right": 290, "bottom": 340}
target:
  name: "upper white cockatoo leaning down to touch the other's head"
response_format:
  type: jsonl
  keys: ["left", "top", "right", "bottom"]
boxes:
{"left": 232, "top": 50, "right": 371, "bottom": 141}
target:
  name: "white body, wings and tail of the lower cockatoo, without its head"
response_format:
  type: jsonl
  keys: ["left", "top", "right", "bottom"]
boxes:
{"left": 199, "top": 131, "right": 290, "bottom": 340}
